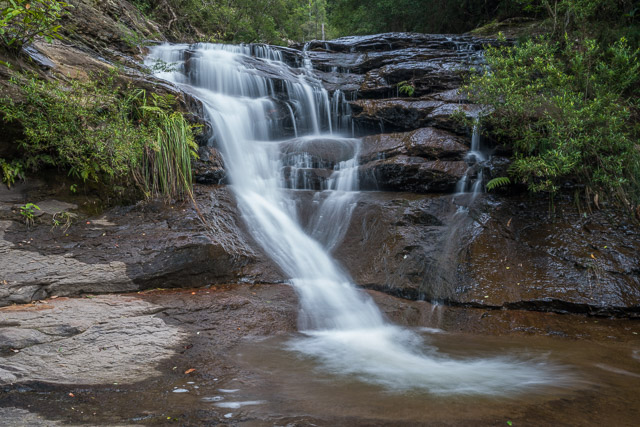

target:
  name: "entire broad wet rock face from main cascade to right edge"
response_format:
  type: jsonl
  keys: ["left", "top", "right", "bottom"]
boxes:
{"left": 335, "top": 193, "right": 640, "bottom": 317}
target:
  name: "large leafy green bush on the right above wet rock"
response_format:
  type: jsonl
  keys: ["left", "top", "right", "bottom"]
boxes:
{"left": 466, "top": 38, "right": 640, "bottom": 203}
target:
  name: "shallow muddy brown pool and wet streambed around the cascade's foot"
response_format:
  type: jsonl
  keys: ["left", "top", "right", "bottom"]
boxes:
{"left": 0, "top": 285, "right": 640, "bottom": 426}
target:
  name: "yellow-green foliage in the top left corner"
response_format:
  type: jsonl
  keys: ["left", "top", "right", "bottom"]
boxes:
{"left": 0, "top": 0, "right": 69, "bottom": 51}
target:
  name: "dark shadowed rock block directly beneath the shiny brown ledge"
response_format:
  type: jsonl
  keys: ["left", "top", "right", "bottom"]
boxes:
{"left": 359, "top": 155, "right": 468, "bottom": 193}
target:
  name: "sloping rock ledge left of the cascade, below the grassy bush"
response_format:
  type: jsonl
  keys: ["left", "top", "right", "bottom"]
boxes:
{"left": 0, "top": 188, "right": 282, "bottom": 306}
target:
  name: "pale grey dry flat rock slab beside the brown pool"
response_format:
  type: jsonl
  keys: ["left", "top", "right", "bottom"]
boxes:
{"left": 0, "top": 295, "right": 185, "bottom": 384}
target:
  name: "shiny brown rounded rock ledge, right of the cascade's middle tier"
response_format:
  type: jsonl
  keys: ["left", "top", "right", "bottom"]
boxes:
{"left": 359, "top": 128, "right": 469, "bottom": 163}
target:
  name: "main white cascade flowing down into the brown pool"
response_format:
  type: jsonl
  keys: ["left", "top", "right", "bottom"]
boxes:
{"left": 149, "top": 44, "right": 560, "bottom": 394}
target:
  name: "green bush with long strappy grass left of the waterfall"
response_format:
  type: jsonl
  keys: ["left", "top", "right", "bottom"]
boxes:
{"left": 0, "top": 73, "right": 195, "bottom": 202}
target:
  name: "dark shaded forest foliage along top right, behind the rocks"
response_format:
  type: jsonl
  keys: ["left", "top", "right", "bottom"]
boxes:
{"left": 327, "top": 0, "right": 639, "bottom": 41}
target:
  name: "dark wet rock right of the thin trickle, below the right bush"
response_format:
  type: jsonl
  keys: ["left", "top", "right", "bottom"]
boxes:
{"left": 453, "top": 197, "right": 640, "bottom": 316}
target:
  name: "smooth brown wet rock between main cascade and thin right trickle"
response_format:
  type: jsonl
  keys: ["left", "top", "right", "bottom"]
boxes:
{"left": 334, "top": 192, "right": 458, "bottom": 299}
